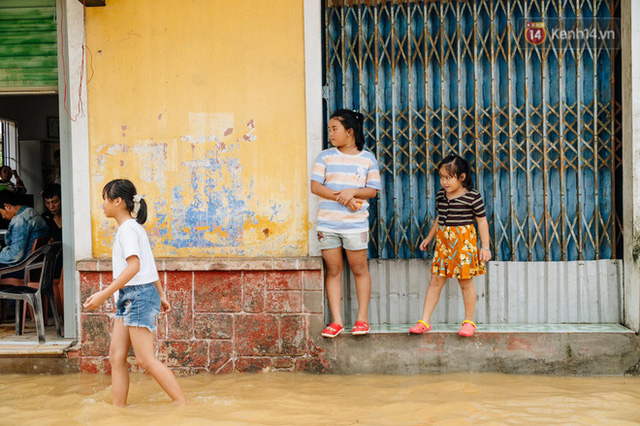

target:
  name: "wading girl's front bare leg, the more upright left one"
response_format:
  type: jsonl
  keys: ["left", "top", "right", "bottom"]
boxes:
{"left": 109, "top": 318, "right": 131, "bottom": 407}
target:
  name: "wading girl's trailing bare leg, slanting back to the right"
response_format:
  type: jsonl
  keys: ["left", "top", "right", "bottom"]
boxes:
{"left": 128, "top": 327, "right": 189, "bottom": 404}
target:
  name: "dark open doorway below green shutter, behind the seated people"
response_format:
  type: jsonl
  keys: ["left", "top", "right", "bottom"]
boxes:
{"left": 0, "top": 94, "right": 64, "bottom": 342}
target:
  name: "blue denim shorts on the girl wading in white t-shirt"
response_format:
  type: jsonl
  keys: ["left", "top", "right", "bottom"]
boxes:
{"left": 116, "top": 283, "right": 160, "bottom": 331}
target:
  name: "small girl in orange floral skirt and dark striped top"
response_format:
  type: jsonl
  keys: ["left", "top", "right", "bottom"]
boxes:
{"left": 409, "top": 154, "right": 491, "bottom": 337}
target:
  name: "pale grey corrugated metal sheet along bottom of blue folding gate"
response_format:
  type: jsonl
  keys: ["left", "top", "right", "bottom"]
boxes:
{"left": 338, "top": 259, "right": 622, "bottom": 324}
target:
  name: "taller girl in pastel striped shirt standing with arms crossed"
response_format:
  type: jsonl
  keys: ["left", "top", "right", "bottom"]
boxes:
{"left": 311, "top": 109, "right": 381, "bottom": 338}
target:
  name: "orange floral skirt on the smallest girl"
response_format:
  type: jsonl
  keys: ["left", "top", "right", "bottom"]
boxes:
{"left": 431, "top": 225, "right": 487, "bottom": 280}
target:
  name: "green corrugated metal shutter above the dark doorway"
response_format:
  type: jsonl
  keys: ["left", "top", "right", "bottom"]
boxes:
{"left": 0, "top": 0, "right": 58, "bottom": 92}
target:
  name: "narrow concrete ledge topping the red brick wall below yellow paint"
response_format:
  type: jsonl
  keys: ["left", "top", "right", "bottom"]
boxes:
{"left": 76, "top": 257, "right": 322, "bottom": 272}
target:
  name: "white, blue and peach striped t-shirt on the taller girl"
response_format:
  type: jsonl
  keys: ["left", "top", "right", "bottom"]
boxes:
{"left": 311, "top": 148, "right": 382, "bottom": 233}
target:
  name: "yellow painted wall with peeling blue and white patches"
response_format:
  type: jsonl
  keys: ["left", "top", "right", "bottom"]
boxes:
{"left": 86, "top": 0, "right": 308, "bottom": 257}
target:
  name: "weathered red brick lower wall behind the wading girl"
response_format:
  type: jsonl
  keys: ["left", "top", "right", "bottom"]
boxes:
{"left": 78, "top": 260, "right": 324, "bottom": 373}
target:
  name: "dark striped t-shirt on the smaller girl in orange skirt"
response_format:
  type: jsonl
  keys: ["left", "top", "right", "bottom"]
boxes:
{"left": 436, "top": 188, "right": 487, "bottom": 226}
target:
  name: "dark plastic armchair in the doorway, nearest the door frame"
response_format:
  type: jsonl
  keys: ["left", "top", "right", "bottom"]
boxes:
{"left": 0, "top": 242, "right": 62, "bottom": 343}
